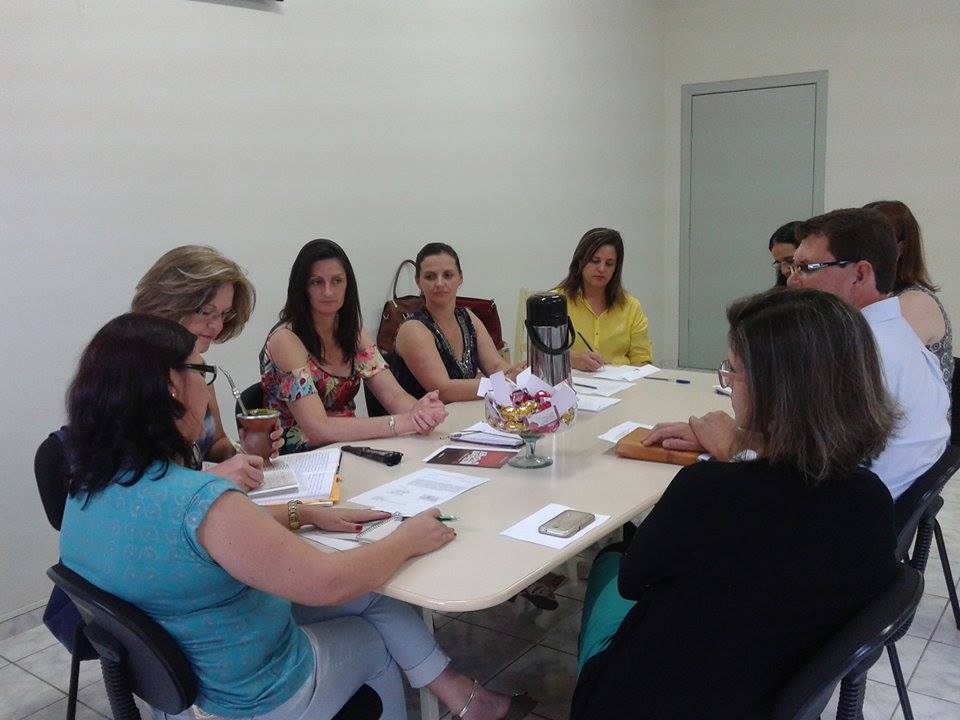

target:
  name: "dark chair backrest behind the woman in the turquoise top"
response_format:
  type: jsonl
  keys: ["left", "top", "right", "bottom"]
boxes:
{"left": 47, "top": 563, "right": 197, "bottom": 714}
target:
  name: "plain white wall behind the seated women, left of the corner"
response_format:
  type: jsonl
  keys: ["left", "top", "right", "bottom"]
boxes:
{"left": 0, "top": 0, "right": 668, "bottom": 618}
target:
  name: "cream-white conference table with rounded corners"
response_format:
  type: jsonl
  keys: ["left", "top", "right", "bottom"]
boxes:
{"left": 308, "top": 370, "right": 730, "bottom": 719}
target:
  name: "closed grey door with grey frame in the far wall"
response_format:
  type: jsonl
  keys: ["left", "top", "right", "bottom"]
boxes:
{"left": 680, "top": 72, "right": 826, "bottom": 369}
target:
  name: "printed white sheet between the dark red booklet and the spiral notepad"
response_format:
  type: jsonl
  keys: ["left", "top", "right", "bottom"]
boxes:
{"left": 350, "top": 468, "right": 489, "bottom": 515}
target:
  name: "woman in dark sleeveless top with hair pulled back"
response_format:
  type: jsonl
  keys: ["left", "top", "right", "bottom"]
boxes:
{"left": 389, "top": 243, "right": 523, "bottom": 403}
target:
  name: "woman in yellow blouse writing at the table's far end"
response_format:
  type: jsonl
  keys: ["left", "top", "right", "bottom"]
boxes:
{"left": 557, "top": 228, "right": 653, "bottom": 372}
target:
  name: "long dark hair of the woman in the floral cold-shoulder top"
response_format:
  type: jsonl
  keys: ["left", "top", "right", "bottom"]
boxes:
{"left": 280, "top": 239, "right": 363, "bottom": 363}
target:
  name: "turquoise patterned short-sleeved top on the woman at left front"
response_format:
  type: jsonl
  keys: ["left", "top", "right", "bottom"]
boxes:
{"left": 60, "top": 462, "right": 315, "bottom": 717}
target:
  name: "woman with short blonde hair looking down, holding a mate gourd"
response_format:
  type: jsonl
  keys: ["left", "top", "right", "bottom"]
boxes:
{"left": 130, "top": 245, "right": 281, "bottom": 490}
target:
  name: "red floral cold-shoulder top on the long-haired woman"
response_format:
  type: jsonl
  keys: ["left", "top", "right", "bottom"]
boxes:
{"left": 260, "top": 325, "right": 387, "bottom": 455}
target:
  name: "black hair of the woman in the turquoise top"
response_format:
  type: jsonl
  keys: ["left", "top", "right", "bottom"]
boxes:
{"left": 67, "top": 313, "right": 196, "bottom": 499}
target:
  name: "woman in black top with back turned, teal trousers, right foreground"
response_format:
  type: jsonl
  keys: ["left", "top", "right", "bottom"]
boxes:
{"left": 571, "top": 289, "right": 896, "bottom": 720}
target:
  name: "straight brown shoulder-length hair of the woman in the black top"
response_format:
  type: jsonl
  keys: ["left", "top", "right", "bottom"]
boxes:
{"left": 727, "top": 288, "right": 898, "bottom": 485}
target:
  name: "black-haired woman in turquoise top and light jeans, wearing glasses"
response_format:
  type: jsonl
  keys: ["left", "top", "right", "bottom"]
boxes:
{"left": 60, "top": 314, "right": 532, "bottom": 720}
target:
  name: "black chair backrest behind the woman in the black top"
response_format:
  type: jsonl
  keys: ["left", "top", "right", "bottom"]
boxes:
{"left": 772, "top": 563, "right": 923, "bottom": 720}
